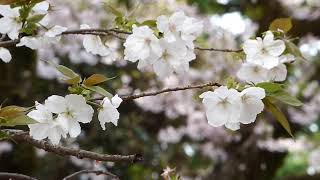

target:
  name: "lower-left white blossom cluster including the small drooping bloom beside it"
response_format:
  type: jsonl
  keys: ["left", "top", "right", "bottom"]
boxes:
{"left": 28, "top": 94, "right": 122, "bottom": 144}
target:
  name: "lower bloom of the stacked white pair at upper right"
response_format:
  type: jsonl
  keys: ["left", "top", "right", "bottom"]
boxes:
{"left": 237, "top": 63, "right": 269, "bottom": 83}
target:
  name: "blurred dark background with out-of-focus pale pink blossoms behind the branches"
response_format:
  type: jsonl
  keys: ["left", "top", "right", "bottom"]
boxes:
{"left": 0, "top": 0, "right": 320, "bottom": 180}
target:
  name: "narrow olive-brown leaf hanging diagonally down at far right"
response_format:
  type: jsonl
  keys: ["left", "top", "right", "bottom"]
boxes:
{"left": 263, "top": 98, "right": 294, "bottom": 137}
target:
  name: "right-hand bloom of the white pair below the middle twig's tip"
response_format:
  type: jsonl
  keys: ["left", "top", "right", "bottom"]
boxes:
{"left": 239, "top": 87, "right": 266, "bottom": 124}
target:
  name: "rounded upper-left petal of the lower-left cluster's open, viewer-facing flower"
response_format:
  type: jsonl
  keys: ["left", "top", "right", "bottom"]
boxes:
{"left": 45, "top": 95, "right": 67, "bottom": 113}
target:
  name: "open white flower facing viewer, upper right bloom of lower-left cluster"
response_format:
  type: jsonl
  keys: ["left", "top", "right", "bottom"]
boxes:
{"left": 45, "top": 94, "right": 93, "bottom": 137}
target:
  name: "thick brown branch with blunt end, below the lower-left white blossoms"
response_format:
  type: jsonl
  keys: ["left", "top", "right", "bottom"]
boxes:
{"left": 4, "top": 129, "right": 143, "bottom": 163}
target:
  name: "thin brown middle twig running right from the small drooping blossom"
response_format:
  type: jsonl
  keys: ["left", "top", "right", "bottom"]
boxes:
{"left": 90, "top": 82, "right": 221, "bottom": 101}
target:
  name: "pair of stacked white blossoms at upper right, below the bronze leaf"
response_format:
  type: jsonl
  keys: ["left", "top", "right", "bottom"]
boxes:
{"left": 237, "top": 31, "right": 295, "bottom": 83}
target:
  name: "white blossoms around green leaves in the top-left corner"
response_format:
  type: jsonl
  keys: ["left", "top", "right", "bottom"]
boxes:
{"left": 0, "top": 1, "right": 49, "bottom": 63}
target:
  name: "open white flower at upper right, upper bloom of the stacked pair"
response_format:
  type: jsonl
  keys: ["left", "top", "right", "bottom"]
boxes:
{"left": 243, "top": 31, "right": 286, "bottom": 69}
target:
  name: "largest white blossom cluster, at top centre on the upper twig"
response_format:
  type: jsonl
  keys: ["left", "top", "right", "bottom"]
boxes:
{"left": 124, "top": 12, "right": 203, "bottom": 78}
